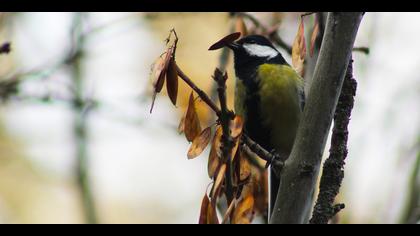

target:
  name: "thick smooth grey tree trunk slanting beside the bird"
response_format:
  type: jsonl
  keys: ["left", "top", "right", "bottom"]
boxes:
{"left": 270, "top": 12, "right": 363, "bottom": 223}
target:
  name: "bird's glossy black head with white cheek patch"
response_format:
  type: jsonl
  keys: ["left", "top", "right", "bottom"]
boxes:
{"left": 227, "top": 35, "right": 287, "bottom": 79}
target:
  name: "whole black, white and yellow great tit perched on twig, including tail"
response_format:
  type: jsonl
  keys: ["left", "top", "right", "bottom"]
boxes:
{"left": 226, "top": 35, "right": 305, "bottom": 218}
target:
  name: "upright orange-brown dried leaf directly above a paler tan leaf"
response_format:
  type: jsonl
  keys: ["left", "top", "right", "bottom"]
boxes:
{"left": 184, "top": 92, "right": 201, "bottom": 142}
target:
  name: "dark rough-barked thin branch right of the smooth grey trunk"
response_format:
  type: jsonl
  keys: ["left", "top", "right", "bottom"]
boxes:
{"left": 310, "top": 56, "right": 357, "bottom": 224}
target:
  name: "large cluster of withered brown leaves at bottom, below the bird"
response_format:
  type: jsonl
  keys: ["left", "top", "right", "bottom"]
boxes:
{"left": 199, "top": 116, "right": 268, "bottom": 224}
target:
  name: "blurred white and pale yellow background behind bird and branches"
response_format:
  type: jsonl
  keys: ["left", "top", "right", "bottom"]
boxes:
{"left": 0, "top": 12, "right": 420, "bottom": 223}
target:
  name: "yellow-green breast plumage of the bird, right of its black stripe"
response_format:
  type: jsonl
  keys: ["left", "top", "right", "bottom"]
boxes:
{"left": 257, "top": 64, "right": 303, "bottom": 153}
